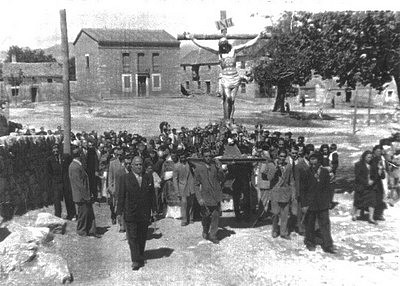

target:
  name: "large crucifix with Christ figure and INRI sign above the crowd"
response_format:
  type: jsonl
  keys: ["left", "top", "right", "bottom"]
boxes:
{"left": 178, "top": 11, "right": 270, "bottom": 123}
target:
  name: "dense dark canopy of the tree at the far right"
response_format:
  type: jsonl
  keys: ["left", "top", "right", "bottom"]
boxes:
{"left": 295, "top": 11, "right": 400, "bottom": 103}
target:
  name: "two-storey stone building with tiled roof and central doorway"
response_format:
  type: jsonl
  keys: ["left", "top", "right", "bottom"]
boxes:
{"left": 73, "top": 29, "right": 180, "bottom": 98}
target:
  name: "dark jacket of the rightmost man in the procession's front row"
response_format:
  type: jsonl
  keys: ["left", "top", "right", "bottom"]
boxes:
{"left": 302, "top": 167, "right": 333, "bottom": 211}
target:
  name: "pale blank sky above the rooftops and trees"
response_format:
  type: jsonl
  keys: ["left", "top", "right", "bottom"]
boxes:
{"left": 0, "top": 0, "right": 400, "bottom": 51}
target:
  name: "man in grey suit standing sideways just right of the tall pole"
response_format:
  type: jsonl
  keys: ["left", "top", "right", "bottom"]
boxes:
{"left": 68, "top": 148, "right": 100, "bottom": 237}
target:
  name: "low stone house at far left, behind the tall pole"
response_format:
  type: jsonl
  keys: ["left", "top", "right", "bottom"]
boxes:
{"left": 0, "top": 60, "right": 62, "bottom": 102}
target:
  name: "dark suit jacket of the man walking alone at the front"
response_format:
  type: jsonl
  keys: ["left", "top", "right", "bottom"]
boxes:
{"left": 117, "top": 173, "right": 155, "bottom": 222}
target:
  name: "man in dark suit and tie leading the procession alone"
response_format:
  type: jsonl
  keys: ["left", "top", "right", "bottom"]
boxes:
{"left": 117, "top": 156, "right": 155, "bottom": 270}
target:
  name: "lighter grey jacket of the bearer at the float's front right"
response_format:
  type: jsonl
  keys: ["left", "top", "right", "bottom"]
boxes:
{"left": 267, "top": 163, "right": 295, "bottom": 203}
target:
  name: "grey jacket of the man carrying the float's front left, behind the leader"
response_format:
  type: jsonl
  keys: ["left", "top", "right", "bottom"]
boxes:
{"left": 194, "top": 163, "right": 224, "bottom": 206}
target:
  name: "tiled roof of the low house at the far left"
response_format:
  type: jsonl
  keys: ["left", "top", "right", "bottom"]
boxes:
{"left": 3, "top": 62, "right": 62, "bottom": 77}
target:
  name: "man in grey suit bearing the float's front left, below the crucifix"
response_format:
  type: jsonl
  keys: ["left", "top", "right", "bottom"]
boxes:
{"left": 194, "top": 149, "right": 224, "bottom": 243}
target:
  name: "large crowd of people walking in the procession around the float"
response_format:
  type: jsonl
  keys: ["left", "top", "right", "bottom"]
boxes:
{"left": 43, "top": 122, "right": 400, "bottom": 269}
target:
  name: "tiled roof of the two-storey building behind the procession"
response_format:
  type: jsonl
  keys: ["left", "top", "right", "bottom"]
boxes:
{"left": 74, "top": 28, "right": 180, "bottom": 47}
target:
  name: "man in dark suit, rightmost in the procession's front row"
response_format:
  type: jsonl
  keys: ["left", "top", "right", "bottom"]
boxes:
{"left": 300, "top": 153, "right": 336, "bottom": 254}
